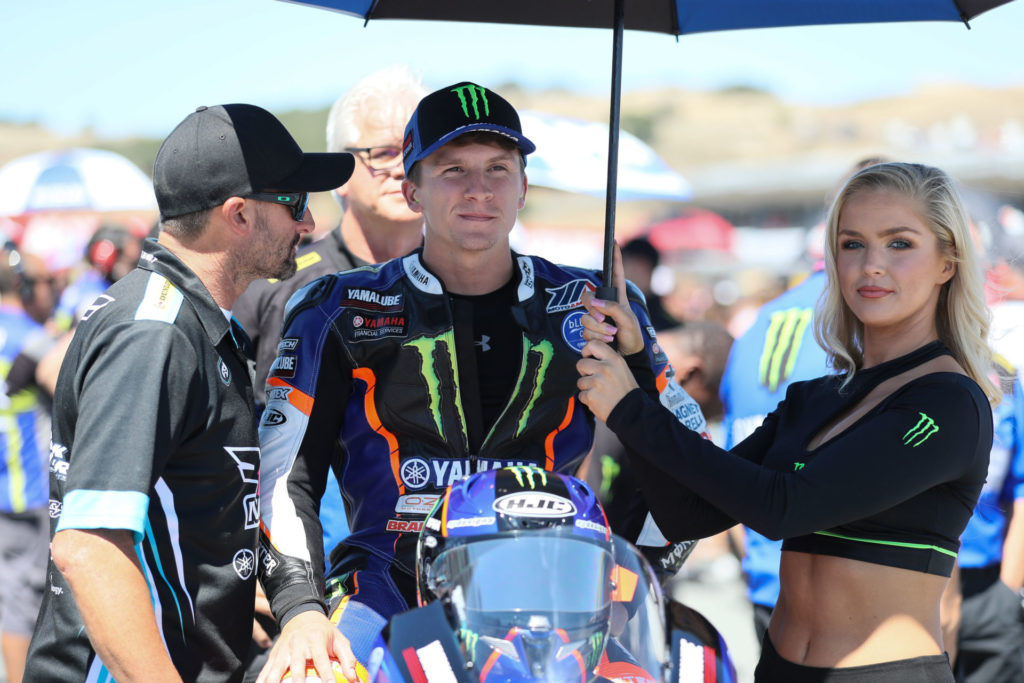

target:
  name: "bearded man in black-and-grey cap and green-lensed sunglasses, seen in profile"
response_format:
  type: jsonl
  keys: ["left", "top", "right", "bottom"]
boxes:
{"left": 26, "top": 104, "right": 353, "bottom": 683}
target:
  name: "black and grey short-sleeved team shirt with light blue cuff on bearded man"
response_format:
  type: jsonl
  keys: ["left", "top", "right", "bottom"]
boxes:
{"left": 26, "top": 241, "right": 259, "bottom": 683}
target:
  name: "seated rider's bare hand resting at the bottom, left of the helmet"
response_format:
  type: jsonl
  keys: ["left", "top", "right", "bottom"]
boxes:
{"left": 256, "top": 610, "right": 358, "bottom": 683}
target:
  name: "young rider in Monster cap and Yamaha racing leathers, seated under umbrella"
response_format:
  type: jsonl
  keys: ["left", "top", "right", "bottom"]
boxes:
{"left": 260, "top": 83, "right": 702, "bottom": 682}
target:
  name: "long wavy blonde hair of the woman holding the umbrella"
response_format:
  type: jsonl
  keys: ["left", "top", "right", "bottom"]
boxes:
{"left": 814, "top": 162, "right": 1000, "bottom": 402}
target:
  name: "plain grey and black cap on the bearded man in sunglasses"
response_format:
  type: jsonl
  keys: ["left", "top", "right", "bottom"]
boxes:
{"left": 153, "top": 104, "right": 355, "bottom": 218}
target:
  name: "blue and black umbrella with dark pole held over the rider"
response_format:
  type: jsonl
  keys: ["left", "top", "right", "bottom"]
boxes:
{"left": 280, "top": 0, "right": 1011, "bottom": 298}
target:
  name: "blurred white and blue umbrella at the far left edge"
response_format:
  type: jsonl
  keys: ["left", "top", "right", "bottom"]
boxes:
{"left": 0, "top": 147, "right": 157, "bottom": 216}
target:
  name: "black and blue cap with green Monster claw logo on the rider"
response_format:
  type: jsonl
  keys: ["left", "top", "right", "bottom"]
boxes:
{"left": 401, "top": 81, "right": 537, "bottom": 175}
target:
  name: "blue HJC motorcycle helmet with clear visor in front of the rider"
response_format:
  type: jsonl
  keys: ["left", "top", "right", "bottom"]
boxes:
{"left": 417, "top": 467, "right": 615, "bottom": 683}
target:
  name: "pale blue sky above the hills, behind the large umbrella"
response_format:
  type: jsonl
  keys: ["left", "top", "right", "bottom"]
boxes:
{"left": 0, "top": 0, "right": 1024, "bottom": 137}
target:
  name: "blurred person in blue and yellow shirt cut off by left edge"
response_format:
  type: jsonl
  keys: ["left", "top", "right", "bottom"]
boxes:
{"left": 0, "top": 243, "right": 53, "bottom": 683}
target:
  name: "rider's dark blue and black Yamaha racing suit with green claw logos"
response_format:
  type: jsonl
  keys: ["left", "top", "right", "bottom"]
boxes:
{"left": 260, "top": 251, "right": 702, "bottom": 630}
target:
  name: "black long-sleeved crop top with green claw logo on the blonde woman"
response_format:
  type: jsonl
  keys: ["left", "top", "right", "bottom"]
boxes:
{"left": 608, "top": 341, "right": 992, "bottom": 577}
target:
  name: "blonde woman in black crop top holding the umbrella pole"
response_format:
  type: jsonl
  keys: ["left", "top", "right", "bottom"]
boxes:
{"left": 578, "top": 163, "right": 998, "bottom": 683}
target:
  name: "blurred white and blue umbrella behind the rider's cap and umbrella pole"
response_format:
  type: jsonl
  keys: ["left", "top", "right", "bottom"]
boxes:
{"left": 519, "top": 111, "right": 692, "bottom": 202}
